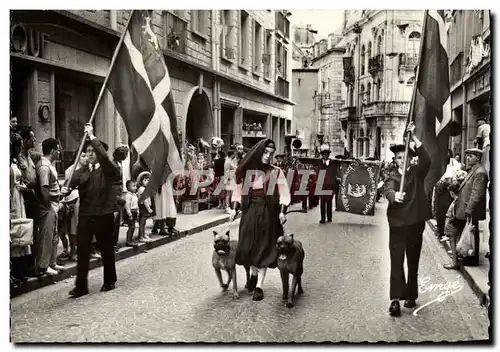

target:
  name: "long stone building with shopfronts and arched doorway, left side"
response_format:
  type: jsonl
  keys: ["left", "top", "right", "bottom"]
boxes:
{"left": 10, "top": 10, "right": 293, "bottom": 172}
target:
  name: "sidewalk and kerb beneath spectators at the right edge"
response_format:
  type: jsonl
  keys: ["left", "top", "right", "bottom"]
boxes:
{"left": 425, "top": 216, "right": 490, "bottom": 306}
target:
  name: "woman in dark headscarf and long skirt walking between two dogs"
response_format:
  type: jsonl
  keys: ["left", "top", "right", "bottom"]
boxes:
{"left": 231, "top": 139, "right": 290, "bottom": 301}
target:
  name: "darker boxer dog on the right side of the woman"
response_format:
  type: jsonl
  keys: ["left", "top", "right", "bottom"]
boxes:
{"left": 276, "top": 234, "right": 305, "bottom": 308}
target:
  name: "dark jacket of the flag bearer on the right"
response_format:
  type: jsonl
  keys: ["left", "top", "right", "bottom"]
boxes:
{"left": 384, "top": 146, "right": 432, "bottom": 227}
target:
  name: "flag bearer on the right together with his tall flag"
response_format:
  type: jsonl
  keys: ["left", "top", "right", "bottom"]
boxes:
{"left": 386, "top": 10, "right": 451, "bottom": 316}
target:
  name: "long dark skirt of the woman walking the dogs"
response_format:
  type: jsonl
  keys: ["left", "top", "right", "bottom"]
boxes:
{"left": 236, "top": 196, "right": 283, "bottom": 268}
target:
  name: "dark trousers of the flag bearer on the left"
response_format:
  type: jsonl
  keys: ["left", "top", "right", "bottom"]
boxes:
{"left": 76, "top": 214, "right": 117, "bottom": 290}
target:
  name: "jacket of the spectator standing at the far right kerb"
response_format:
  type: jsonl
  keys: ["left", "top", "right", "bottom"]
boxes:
{"left": 455, "top": 163, "right": 488, "bottom": 220}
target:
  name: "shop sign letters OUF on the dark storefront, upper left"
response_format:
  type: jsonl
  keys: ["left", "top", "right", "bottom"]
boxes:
{"left": 10, "top": 23, "right": 48, "bottom": 58}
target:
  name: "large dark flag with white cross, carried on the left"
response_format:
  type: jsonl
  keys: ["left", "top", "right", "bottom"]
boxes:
{"left": 108, "top": 10, "right": 183, "bottom": 199}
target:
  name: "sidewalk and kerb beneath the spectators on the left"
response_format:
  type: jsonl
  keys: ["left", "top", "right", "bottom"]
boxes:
{"left": 12, "top": 209, "right": 234, "bottom": 297}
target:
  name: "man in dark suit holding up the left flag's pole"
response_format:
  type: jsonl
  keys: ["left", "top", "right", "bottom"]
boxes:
{"left": 62, "top": 124, "right": 120, "bottom": 297}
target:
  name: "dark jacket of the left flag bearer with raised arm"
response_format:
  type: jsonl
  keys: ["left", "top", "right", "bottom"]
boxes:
{"left": 70, "top": 139, "right": 121, "bottom": 216}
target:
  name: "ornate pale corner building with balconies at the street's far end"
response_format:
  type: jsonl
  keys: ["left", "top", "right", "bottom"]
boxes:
{"left": 340, "top": 10, "right": 424, "bottom": 160}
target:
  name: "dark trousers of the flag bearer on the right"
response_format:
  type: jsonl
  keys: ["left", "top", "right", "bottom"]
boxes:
{"left": 389, "top": 221, "right": 425, "bottom": 301}
